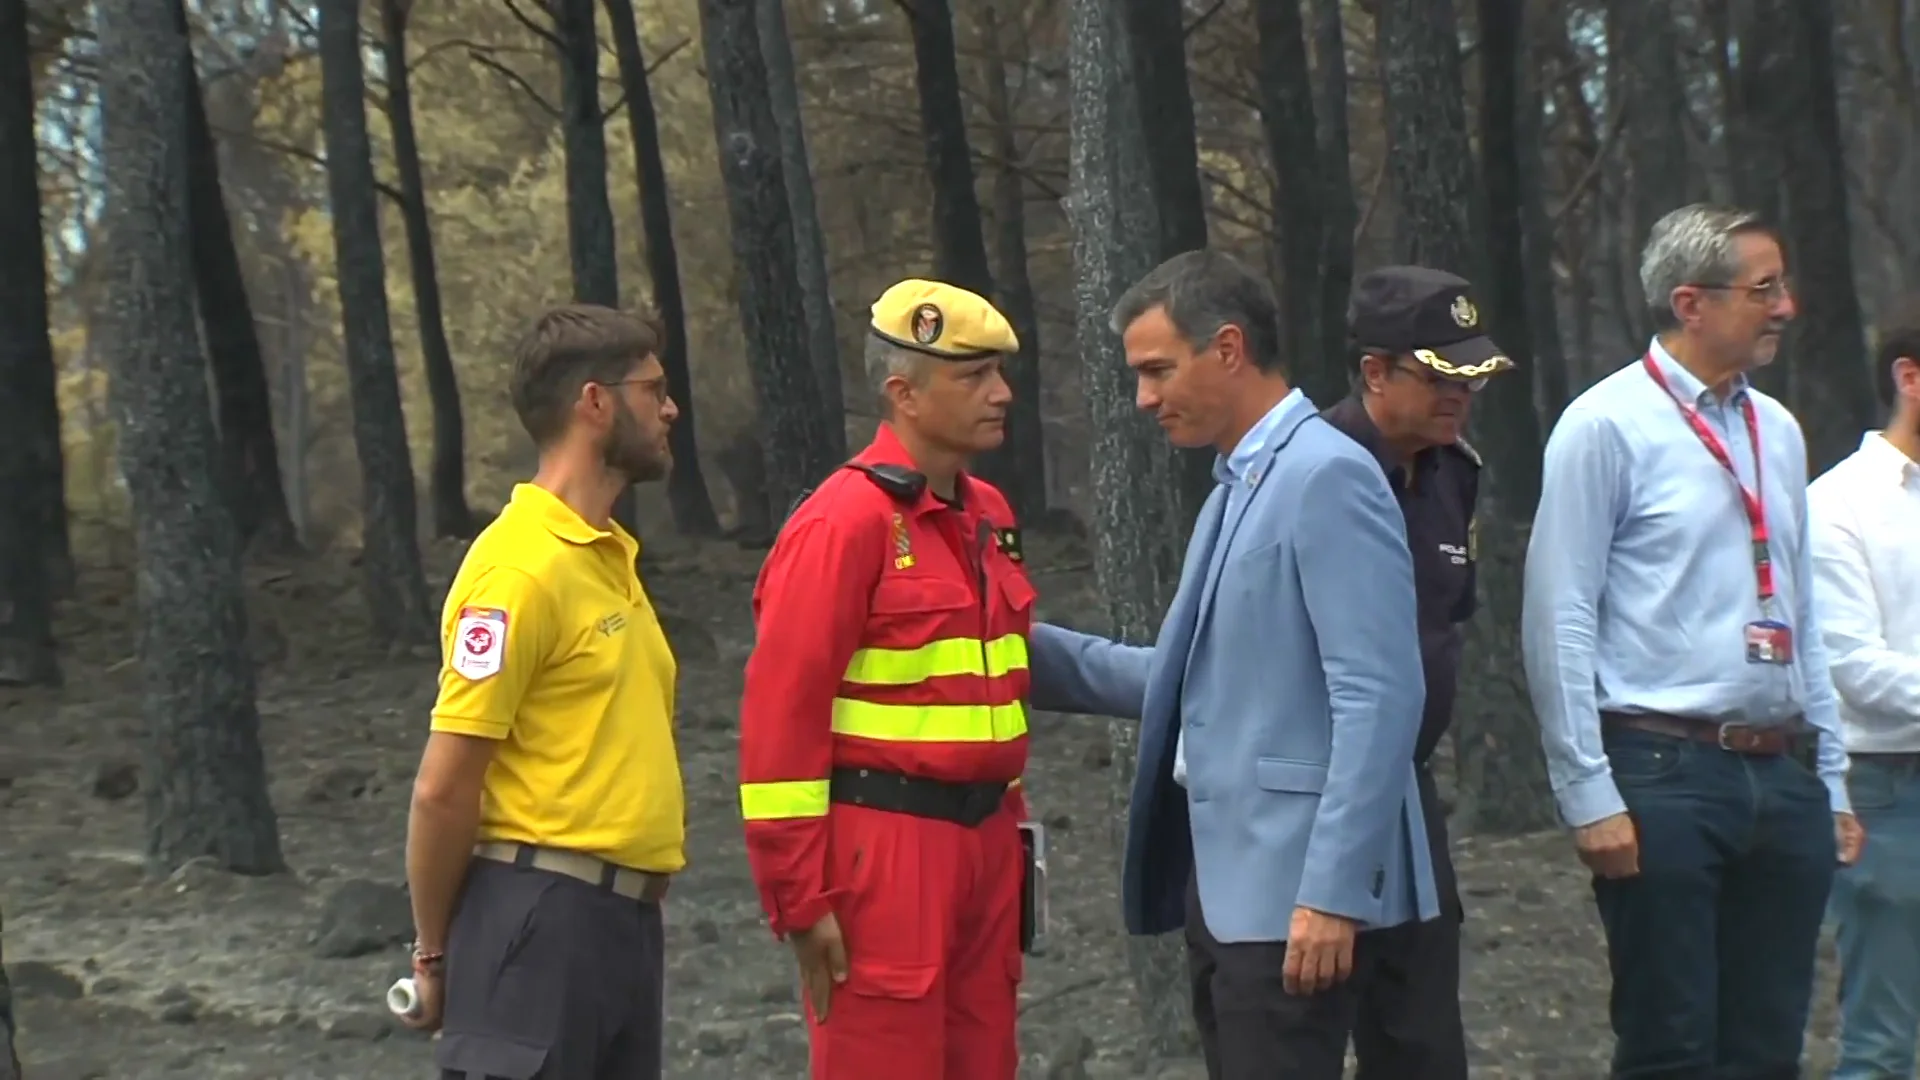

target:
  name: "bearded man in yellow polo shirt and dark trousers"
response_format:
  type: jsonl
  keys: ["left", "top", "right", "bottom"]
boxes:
{"left": 407, "top": 304, "right": 685, "bottom": 1080}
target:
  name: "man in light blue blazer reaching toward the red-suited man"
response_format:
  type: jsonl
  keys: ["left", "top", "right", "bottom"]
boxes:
{"left": 1029, "top": 252, "right": 1440, "bottom": 1080}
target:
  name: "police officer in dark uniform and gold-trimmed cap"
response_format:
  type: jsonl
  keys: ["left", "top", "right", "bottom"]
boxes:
{"left": 1323, "top": 267, "right": 1513, "bottom": 1080}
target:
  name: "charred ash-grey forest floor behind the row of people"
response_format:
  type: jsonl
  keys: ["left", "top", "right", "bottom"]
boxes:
{"left": 0, "top": 526, "right": 1834, "bottom": 1080}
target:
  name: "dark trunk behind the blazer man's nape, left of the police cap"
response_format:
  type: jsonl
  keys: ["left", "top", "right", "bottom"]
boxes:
{"left": 1254, "top": 0, "right": 1348, "bottom": 404}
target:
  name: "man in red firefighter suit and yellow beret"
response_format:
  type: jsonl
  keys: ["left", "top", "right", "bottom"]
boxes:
{"left": 739, "top": 281, "right": 1035, "bottom": 1080}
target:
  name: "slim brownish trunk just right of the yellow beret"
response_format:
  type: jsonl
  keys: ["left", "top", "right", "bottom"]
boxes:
{"left": 979, "top": 0, "right": 1046, "bottom": 521}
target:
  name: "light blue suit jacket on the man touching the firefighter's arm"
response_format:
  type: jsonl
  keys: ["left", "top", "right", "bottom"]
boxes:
{"left": 1029, "top": 392, "right": 1440, "bottom": 942}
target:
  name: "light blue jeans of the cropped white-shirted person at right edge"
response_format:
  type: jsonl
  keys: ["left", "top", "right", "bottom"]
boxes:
{"left": 1834, "top": 755, "right": 1920, "bottom": 1080}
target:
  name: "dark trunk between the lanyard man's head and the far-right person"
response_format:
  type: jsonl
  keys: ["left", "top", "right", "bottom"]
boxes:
{"left": 1780, "top": 0, "right": 1880, "bottom": 475}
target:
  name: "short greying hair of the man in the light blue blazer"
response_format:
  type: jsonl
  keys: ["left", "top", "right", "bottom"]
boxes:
{"left": 1108, "top": 248, "right": 1286, "bottom": 375}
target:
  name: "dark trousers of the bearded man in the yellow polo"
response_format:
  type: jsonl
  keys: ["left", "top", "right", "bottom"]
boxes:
{"left": 434, "top": 859, "right": 664, "bottom": 1080}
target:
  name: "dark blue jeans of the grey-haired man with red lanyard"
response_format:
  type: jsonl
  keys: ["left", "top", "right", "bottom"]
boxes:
{"left": 1594, "top": 726, "right": 1837, "bottom": 1080}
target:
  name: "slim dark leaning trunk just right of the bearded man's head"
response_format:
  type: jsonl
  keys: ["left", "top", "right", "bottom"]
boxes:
{"left": 607, "top": 0, "right": 720, "bottom": 536}
